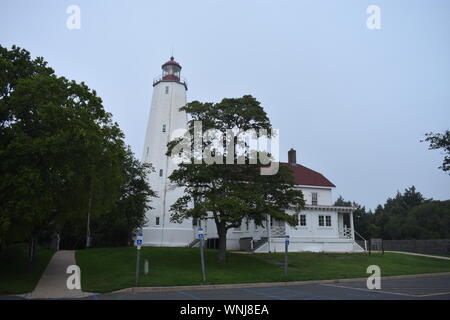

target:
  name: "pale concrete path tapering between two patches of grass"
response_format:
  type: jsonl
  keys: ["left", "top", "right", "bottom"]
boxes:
{"left": 26, "top": 250, "right": 91, "bottom": 299}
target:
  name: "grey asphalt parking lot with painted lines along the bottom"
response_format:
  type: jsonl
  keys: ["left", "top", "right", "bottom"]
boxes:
{"left": 88, "top": 275, "right": 450, "bottom": 300}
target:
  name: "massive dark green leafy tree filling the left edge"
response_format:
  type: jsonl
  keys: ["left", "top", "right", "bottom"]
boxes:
{"left": 0, "top": 46, "right": 153, "bottom": 260}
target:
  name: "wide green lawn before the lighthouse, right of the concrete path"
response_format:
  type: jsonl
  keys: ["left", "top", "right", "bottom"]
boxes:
{"left": 76, "top": 247, "right": 450, "bottom": 292}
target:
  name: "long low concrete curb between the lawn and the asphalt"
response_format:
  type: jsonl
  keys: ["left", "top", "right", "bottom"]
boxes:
{"left": 108, "top": 272, "right": 450, "bottom": 294}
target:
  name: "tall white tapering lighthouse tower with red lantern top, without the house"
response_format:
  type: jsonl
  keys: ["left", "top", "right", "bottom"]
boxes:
{"left": 142, "top": 57, "right": 194, "bottom": 246}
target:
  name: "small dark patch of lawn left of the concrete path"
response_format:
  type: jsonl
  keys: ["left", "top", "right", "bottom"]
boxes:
{"left": 0, "top": 244, "right": 55, "bottom": 294}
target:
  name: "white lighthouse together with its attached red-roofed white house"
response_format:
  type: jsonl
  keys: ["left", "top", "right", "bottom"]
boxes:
{"left": 142, "top": 57, "right": 364, "bottom": 252}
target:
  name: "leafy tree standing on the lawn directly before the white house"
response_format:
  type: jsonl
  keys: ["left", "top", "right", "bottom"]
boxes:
{"left": 167, "top": 95, "right": 304, "bottom": 262}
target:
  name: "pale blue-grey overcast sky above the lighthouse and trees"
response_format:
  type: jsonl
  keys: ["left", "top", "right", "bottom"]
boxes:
{"left": 0, "top": 0, "right": 450, "bottom": 208}
